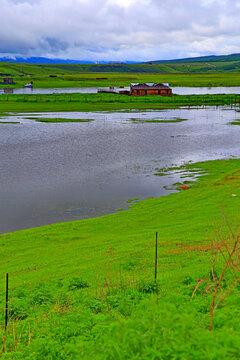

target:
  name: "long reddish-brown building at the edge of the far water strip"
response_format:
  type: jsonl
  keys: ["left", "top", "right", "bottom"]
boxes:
{"left": 130, "top": 83, "right": 172, "bottom": 96}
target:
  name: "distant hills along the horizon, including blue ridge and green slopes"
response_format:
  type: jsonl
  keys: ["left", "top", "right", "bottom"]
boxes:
{"left": 0, "top": 54, "right": 240, "bottom": 76}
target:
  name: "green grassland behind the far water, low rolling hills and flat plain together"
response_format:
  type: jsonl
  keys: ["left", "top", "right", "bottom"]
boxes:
{"left": 0, "top": 62, "right": 240, "bottom": 88}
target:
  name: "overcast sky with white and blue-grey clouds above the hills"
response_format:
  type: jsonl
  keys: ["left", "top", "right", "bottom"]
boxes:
{"left": 0, "top": 0, "right": 240, "bottom": 61}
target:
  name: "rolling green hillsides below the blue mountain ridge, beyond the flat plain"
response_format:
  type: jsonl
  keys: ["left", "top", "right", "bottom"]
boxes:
{"left": 0, "top": 56, "right": 240, "bottom": 75}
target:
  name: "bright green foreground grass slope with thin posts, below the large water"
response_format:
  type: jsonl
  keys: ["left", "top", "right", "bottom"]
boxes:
{"left": 0, "top": 160, "right": 240, "bottom": 360}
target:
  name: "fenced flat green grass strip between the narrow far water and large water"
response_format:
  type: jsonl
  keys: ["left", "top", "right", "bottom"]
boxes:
{"left": 0, "top": 93, "right": 240, "bottom": 114}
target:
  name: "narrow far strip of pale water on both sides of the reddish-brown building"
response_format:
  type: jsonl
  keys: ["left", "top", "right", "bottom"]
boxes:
{"left": 0, "top": 86, "right": 240, "bottom": 95}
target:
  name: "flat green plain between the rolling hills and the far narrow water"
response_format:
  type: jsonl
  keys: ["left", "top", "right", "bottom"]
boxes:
{"left": 2, "top": 73, "right": 240, "bottom": 88}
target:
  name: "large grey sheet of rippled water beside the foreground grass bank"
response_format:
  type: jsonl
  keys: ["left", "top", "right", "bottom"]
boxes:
{"left": 0, "top": 107, "right": 240, "bottom": 233}
